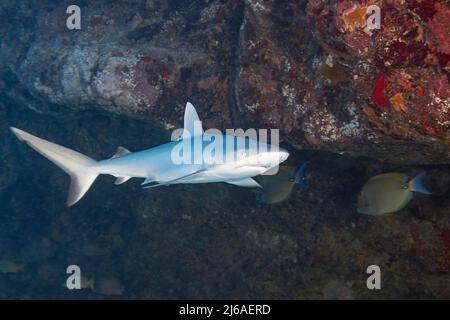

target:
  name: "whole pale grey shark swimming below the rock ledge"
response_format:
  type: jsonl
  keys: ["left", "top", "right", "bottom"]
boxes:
{"left": 10, "top": 102, "right": 289, "bottom": 206}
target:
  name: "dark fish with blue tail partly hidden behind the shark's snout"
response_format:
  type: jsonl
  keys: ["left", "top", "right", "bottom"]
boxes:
{"left": 257, "top": 161, "right": 309, "bottom": 204}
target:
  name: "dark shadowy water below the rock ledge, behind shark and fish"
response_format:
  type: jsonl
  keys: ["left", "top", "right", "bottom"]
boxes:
{"left": 0, "top": 98, "right": 450, "bottom": 299}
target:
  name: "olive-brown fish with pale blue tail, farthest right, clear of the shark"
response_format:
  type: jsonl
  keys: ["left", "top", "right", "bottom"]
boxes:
{"left": 357, "top": 171, "right": 432, "bottom": 215}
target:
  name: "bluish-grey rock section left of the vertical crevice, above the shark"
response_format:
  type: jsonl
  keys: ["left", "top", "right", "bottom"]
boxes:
{"left": 0, "top": 1, "right": 235, "bottom": 127}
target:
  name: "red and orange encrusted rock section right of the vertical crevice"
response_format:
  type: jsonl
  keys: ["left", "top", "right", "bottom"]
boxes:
{"left": 238, "top": 0, "right": 450, "bottom": 163}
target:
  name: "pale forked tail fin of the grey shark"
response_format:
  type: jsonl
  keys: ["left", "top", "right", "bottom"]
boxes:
{"left": 10, "top": 127, "right": 98, "bottom": 206}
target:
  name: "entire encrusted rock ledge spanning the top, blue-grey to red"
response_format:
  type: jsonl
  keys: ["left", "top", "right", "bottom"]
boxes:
{"left": 0, "top": 0, "right": 450, "bottom": 164}
